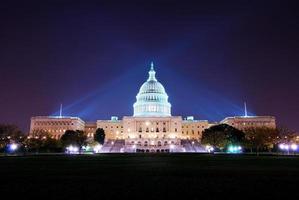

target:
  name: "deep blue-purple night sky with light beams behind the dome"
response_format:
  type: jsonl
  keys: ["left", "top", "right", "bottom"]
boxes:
{"left": 0, "top": 0, "right": 299, "bottom": 131}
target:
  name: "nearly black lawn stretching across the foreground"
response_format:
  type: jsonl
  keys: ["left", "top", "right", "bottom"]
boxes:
{"left": 0, "top": 154, "right": 299, "bottom": 199}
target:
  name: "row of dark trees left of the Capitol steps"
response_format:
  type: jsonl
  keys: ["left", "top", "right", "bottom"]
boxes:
{"left": 0, "top": 124, "right": 105, "bottom": 153}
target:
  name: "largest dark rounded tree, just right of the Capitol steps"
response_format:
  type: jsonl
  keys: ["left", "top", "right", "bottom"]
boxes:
{"left": 201, "top": 124, "right": 245, "bottom": 150}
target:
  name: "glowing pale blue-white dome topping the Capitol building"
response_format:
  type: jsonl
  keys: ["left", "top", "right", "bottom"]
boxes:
{"left": 133, "top": 63, "right": 171, "bottom": 117}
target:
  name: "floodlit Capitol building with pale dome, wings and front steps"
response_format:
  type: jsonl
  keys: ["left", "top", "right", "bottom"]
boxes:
{"left": 30, "top": 63, "right": 276, "bottom": 152}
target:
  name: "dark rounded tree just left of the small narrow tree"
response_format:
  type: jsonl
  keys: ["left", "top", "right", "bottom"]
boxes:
{"left": 60, "top": 130, "right": 87, "bottom": 148}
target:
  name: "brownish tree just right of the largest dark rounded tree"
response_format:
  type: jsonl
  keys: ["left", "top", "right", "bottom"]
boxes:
{"left": 244, "top": 127, "right": 279, "bottom": 154}
